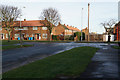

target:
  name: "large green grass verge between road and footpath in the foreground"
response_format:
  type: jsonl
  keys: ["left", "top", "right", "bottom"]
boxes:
{"left": 3, "top": 47, "right": 98, "bottom": 80}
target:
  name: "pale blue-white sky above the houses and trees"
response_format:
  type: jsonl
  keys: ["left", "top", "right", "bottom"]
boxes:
{"left": 0, "top": 0, "right": 118, "bottom": 34}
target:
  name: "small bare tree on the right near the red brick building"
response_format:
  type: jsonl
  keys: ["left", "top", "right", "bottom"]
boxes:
{"left": 101, "top": 19, "right": 116, "bottom": 42}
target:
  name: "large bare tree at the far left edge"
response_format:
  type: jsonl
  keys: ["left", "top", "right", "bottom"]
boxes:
{"left": 0, "top": 5, "right": 21, "bottom": 42}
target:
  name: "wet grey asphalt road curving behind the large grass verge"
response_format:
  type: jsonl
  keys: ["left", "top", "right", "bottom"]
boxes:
{"left": 2, "top": 42, "right": 115, "bottom": 72}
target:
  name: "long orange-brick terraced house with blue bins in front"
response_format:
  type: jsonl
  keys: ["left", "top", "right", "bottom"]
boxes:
{"left": 0, "top": 19, "right": 49, "bottom": 40}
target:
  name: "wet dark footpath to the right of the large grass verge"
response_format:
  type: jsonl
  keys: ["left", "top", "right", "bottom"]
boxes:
{"left": 80, "top": 45, "right": 120, "bottom": 80}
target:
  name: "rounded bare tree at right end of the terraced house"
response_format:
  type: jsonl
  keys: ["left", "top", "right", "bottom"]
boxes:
{"left": 40, "top": 8, "right": 61, "bottom": 41}
